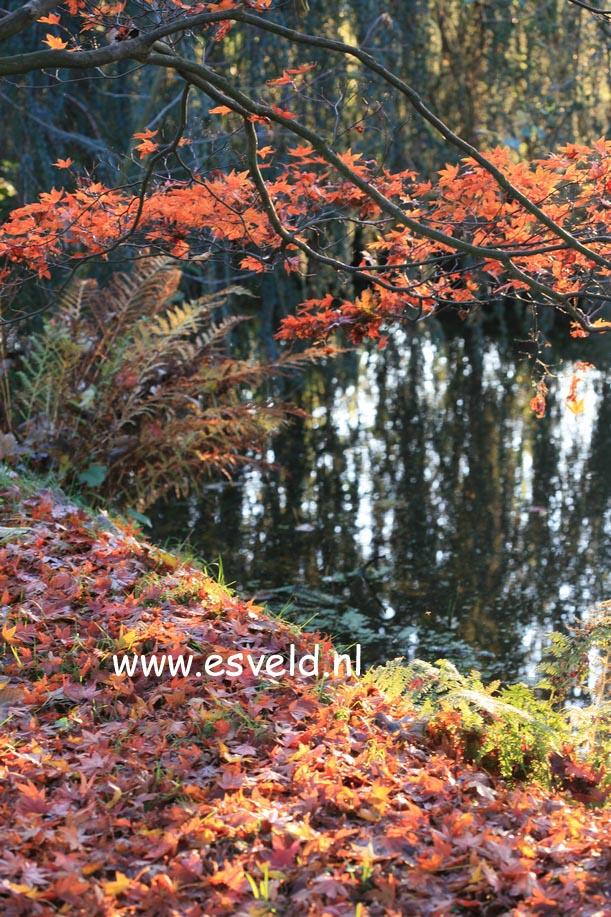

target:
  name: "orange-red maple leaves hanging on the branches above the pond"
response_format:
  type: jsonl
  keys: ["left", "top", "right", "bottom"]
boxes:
{"left": 0, "top": 141, "right": 611, "bottom": 414}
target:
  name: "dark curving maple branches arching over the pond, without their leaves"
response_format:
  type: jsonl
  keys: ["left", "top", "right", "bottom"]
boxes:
{"left": 0, "top": 0, "right": 611, "bottom": 330}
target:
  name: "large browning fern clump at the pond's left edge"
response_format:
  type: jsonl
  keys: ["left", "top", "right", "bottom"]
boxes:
{"left": 14, "top": 258, "right": 328, "bottom": 510}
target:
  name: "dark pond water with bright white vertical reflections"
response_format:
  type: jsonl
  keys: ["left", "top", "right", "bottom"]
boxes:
{"left": 153, "top": 333, "right": 611, "bottom": 681}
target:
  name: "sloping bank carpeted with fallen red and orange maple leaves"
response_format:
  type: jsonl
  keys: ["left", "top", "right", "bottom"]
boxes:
{"left": 0, "top": 486, "right": 611, "bottom": 917}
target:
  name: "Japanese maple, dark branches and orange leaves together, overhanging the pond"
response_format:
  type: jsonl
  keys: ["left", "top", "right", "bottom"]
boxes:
{"left": 0, "top": 0, "right": 611, "bottom": 413}
